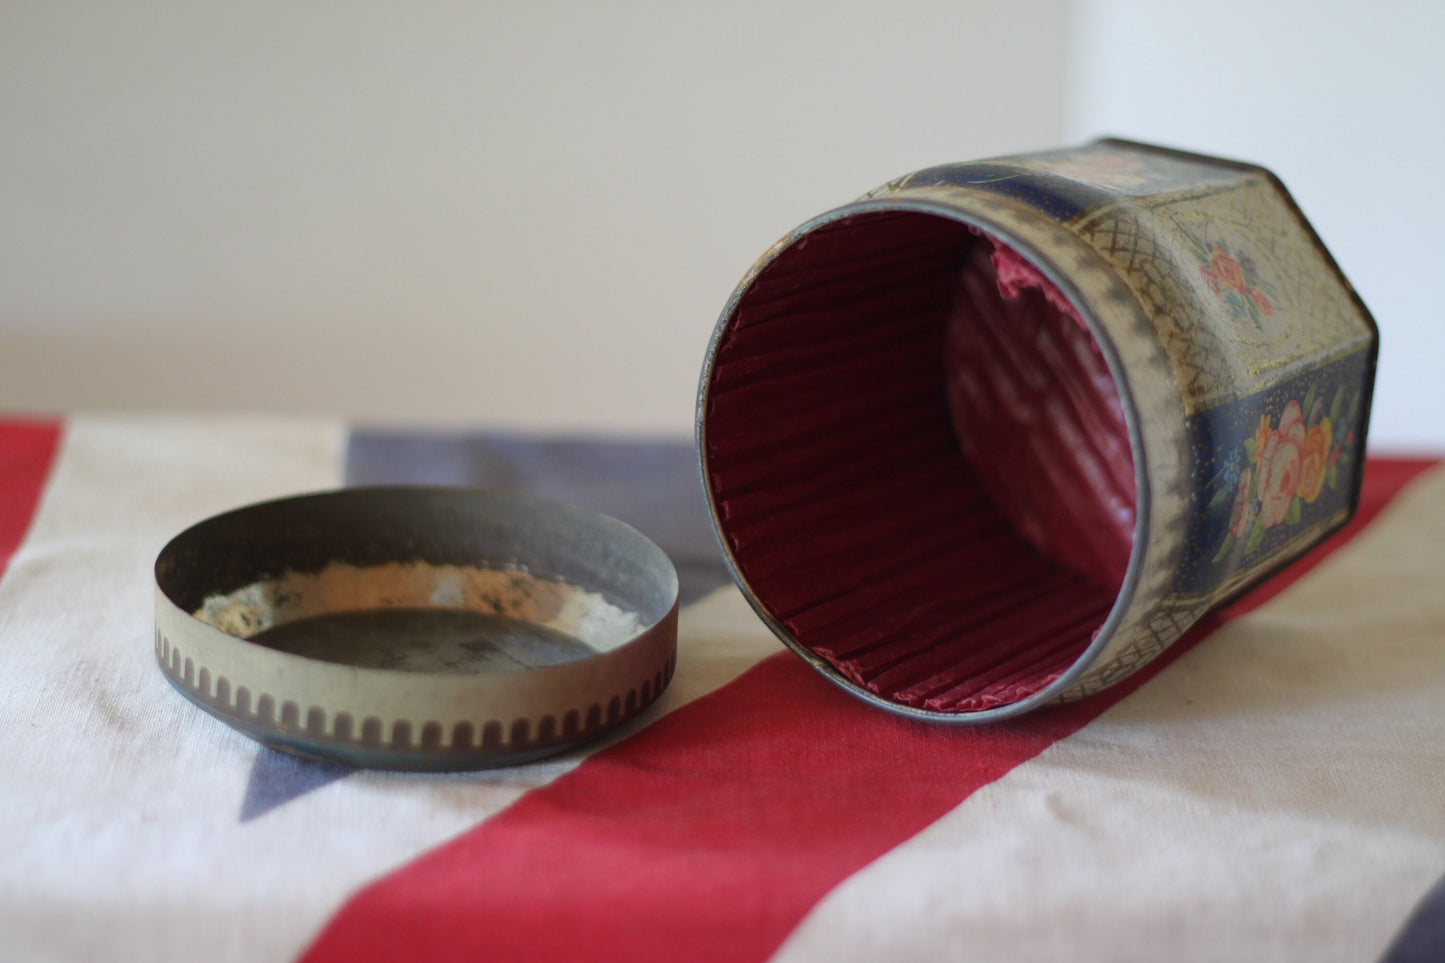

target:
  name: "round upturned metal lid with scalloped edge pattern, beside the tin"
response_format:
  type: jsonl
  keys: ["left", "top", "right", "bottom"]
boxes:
{"left": 155, "top": 487, "right": 678, "bottom": 771}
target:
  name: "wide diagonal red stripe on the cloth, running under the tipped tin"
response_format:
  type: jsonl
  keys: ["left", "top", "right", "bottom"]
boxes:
{"left": 303, "top": 460, "right": 1435, "bottom": 963}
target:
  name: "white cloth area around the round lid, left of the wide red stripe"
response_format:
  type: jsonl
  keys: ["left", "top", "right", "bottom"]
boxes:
{"left": 0, "top": 416, "right": 777, "bottom": 960}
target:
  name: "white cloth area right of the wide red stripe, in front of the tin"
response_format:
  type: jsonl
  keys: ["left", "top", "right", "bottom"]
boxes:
{"left": 775, "top": 468, "right": 1445, "bottom": 963}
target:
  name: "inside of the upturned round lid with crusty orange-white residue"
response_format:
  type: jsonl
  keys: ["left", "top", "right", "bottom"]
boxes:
{"left": 156, "top": 487, "right": 676, "bottom": 672}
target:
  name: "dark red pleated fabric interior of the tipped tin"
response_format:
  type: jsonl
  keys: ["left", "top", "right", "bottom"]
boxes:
{"left": 704, "top": 211, "right": 1134, "bottom": 713}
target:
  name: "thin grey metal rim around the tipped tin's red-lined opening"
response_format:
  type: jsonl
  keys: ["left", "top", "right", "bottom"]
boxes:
{"left": 694, "top": 197, "right": 1163, "bottom": 724}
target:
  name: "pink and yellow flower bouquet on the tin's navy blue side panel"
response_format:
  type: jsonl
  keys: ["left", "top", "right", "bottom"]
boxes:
{"left": 1209, "top": 388, "right": 1360, "bottom": 565}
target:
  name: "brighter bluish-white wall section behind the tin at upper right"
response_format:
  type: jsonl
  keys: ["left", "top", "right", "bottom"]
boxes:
{"left": 1065, "top": 0, "right": 1445, "bottom": 453}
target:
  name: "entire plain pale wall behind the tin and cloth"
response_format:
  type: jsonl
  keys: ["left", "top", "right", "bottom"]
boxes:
{"left": 0, "top": 0, "right": 1445, "bottom": 450}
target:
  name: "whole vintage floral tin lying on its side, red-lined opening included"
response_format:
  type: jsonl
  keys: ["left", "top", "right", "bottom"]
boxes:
{"left": 696, "top": 140, "right": 1379, "bottom": 722}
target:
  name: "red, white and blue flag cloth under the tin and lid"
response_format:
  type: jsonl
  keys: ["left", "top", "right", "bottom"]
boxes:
{"left": 0, "top": 415, "right": 1445, "bottom": 963}
